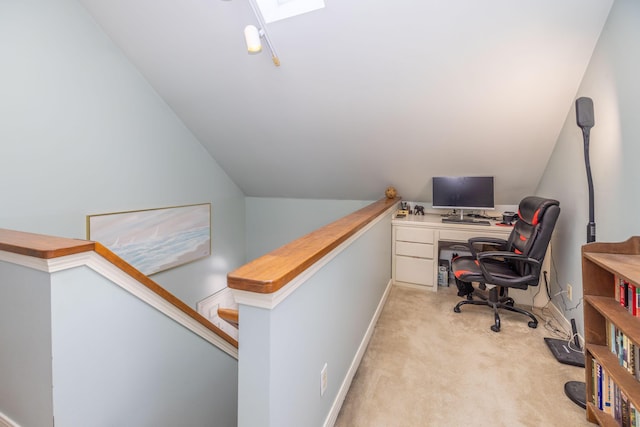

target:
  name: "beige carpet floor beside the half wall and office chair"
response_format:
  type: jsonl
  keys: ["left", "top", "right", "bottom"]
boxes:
{"left": 335, "top": 286, "right": 593, "bottom": 427}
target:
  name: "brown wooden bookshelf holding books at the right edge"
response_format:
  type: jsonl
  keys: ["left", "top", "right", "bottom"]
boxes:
{"left": 582, "top": 236, "right": 640, "bottom": 426}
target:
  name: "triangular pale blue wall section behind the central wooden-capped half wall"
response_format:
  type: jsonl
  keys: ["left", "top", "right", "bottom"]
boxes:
{"left": 245, "top": 197, "right": 371, "bottom": 260}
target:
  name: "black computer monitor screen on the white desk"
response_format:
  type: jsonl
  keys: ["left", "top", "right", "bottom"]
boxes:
{"left": 433, "top": 176, "right": 494, "bottom": 209}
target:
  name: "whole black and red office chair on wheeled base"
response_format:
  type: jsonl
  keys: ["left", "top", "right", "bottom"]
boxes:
{"left": 451, "top": 196, "right": 560, "bottom": 332}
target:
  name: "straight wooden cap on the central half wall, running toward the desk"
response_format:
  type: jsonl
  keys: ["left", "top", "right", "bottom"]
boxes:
{"left": 227, "top": 198, "right": 400, "bottom": 294}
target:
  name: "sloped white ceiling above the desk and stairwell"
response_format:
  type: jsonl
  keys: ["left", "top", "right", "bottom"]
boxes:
{"left": 79, "top": 0, "right": 613, "bottom": 204}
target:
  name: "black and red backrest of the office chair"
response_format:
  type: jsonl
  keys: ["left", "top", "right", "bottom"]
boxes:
{"left": 507, "top": 196, "right": 560, "bottom": 276}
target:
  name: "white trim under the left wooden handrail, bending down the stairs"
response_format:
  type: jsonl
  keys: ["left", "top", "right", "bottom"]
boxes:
{"left": 0, "top": 251, "right": 238, "bottom": 359}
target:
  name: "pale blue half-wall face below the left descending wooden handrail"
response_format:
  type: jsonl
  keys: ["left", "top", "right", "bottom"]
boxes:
{"left": 48, "top": 267, "right": 238, "bottom": 427}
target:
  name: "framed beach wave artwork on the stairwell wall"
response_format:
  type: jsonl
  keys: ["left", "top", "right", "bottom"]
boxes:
{"left": 87, "top": 203, "right": 211, "bottom": 275}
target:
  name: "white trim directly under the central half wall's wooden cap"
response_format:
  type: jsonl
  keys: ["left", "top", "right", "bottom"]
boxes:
{"left": 231, "top": 205, "right": 397, "bottom": 310}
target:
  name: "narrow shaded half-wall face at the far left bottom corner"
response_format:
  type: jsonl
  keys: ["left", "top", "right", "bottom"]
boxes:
{"left": 0, "top": 261, "right": 53, "bottom": 427}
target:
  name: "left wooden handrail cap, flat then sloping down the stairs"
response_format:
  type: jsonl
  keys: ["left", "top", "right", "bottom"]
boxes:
{"left": 0, "top": 228, "right": 238, "bottom": 348}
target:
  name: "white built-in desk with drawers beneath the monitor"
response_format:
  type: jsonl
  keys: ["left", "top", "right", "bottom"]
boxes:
{"left": 391, "top": 214, "right": 512, "bottom": 292}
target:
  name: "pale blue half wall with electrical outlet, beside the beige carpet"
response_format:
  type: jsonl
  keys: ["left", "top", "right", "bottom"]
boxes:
{"left": 238, "top": 212, "right": 391, "bottom": 427}
